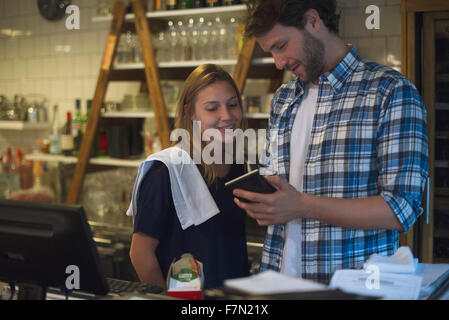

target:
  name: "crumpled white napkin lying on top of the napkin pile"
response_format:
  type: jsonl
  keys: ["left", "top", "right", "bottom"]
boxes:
{"left": 363, "top": 247, "right": 418, "bottom": 273}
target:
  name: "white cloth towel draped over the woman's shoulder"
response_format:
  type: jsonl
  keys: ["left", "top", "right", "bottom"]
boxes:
{"left": 126, "top": 146, "right": 220, "bottom": 230}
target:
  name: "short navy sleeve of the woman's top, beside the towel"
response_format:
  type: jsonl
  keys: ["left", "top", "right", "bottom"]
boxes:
{"left": 134, "top": 161, "right": 173, "bottom": 240}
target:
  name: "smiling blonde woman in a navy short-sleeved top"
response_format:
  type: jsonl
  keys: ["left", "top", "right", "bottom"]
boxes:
{"left": 130, "top": 64, "right": 248, "bottom": 289}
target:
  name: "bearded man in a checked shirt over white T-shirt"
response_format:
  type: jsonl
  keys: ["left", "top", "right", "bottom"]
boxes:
{"left": 234, "top": 0, "right": 428, "bottom": 283}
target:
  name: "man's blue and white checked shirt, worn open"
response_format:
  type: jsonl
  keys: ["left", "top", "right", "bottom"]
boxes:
{"left": 261, "top": 47, "right": 428, "bottom": 283}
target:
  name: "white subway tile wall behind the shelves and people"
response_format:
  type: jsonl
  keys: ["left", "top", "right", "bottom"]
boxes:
{"left": 0, "top": 0, "right": 401, "bottom": 150}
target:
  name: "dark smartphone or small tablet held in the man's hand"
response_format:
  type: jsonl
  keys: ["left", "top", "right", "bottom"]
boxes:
{"left": 225, "top": 169, "right": 276, "bottom": 202}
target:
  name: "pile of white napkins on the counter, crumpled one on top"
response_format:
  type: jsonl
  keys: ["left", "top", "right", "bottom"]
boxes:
{"left": 330, "top": 247, "right": 422, "bottom": 300}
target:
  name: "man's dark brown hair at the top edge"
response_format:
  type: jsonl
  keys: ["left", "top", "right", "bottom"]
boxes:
{"left": 245, "top": 0, "right": 340, "bottom": 37}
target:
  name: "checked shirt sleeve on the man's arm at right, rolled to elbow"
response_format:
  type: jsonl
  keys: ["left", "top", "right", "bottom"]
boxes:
{"left": 377, "top": 80, "right": 429, "bottom": 232}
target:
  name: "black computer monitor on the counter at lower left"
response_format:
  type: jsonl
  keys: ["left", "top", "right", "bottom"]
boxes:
{"left": 0, "top": 200, "right": 108, "bottom": 295}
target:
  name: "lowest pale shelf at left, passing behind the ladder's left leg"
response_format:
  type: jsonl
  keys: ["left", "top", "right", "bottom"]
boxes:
{"left": 25, "top": 153, "right": 144, "bottom": 168}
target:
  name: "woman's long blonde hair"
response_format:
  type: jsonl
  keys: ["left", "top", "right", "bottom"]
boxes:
{"left": 174, "top": 64, "right": 247, "bottom": 186}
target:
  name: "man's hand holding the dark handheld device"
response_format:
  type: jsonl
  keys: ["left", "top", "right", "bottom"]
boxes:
{"left": 233, "top": 176, "right": 301, "bottom": 226}
